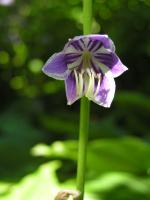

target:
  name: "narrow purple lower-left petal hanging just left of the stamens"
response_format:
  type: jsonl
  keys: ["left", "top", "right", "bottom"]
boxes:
{"left": 65, "top": 73, "right": 79, "bottom": 105}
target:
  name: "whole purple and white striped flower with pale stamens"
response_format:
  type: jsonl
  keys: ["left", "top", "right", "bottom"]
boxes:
{"left": 43, "top": 35, "right": 127, "bottom": 107}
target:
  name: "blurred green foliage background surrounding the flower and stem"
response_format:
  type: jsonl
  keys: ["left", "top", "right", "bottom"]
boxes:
{"left": 0, "top": 0, "right": 150, "bottom": 200}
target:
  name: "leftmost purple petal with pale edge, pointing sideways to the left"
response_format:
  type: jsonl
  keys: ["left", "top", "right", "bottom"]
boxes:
{"left": 42, "top": 52, "right": 69, "bottom": 80}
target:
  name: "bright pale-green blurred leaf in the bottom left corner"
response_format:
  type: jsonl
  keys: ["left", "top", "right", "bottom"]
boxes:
{"left": 0, "top": 161, "right": 60, "bottom": 200}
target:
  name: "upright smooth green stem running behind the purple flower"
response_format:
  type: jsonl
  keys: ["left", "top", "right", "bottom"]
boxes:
{"left": 77, "top": 0, "right": 92, "bottom": 200}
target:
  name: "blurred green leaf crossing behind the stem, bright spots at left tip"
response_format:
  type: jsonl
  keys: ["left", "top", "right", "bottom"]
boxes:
{"left": 32, "top": 137, "right": 150, "bottom": 176}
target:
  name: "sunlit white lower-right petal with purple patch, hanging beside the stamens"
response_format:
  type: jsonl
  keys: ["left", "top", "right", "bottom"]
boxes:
{"left": 92, "top": 71, "right": 116, "bottom": 108}
